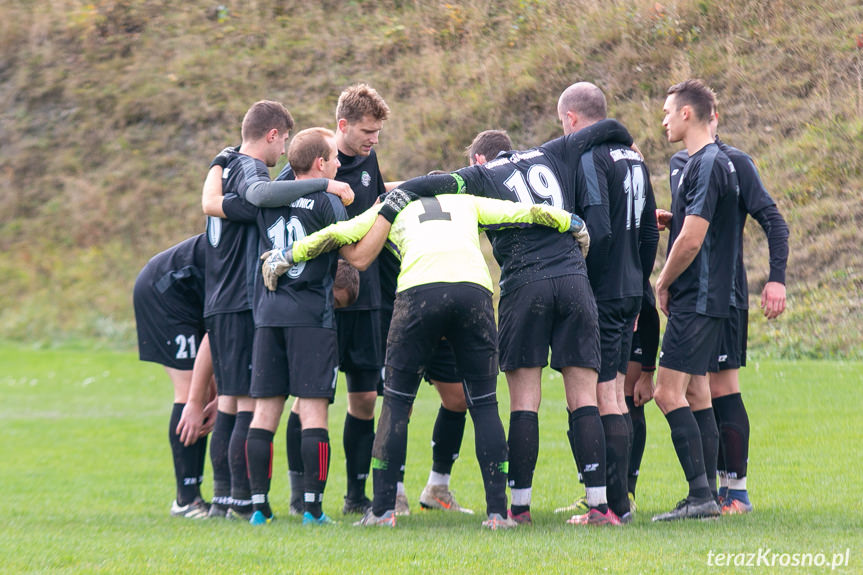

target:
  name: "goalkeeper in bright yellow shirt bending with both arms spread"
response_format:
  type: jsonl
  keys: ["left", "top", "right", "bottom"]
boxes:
{"left": 264, "top": 190, "right": 588, "bottom": 529}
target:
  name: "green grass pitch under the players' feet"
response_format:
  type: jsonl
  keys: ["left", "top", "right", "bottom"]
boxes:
{"left": 0, "top": 347, "right": 863, "bottom": 574}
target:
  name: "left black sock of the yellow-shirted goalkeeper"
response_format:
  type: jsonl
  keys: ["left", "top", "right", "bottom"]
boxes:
{"left": 372, "top": 395, "right": 413, "bottom": 517}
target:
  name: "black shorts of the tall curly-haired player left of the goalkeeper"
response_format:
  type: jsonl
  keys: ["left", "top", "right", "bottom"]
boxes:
{"left": 336, "top": 310, "right": 384, "bottom": 376}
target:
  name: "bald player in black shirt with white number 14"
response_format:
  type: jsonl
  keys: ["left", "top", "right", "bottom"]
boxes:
{"left": 557, "top": 82, "right": 659, "bottom": 523}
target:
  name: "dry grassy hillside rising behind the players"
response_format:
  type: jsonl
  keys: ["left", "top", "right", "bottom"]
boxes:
{"left": 0, "top": 0, "right": 863, "bottom": 357}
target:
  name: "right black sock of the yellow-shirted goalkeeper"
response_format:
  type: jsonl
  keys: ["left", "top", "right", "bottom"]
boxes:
{"left": 469, "top": 400, "right": 509, "bottom": 517}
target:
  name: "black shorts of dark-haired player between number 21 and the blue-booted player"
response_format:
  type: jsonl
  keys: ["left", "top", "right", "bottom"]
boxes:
{"left": 204, "top": 311, "right": 255, "bottom": 396}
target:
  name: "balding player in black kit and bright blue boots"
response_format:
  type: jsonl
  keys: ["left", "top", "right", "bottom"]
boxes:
{"left": 246, "top": 128, "right": 372, "bottom": 525}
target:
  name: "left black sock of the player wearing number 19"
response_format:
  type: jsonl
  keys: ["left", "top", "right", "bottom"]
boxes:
{"left": 507, "top": 411, "right": 539, "bottom": 515}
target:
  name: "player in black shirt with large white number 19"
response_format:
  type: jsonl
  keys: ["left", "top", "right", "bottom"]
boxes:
{"left": 392, "top": 120, "right": 632, "bottom": 524}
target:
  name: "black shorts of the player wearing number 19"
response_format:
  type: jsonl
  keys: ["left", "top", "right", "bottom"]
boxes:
{"left": 498, "top": 274, "right": 599, "bottom": 371}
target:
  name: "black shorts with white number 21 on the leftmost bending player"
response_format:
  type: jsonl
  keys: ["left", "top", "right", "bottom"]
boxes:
{"left": 132, "top": 283, "right": 206, "bottom": 371}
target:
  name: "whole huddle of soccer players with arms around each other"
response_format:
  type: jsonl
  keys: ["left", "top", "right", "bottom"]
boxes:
{"left": 134, "top": 80, "right": 788, "bottom": 530}
